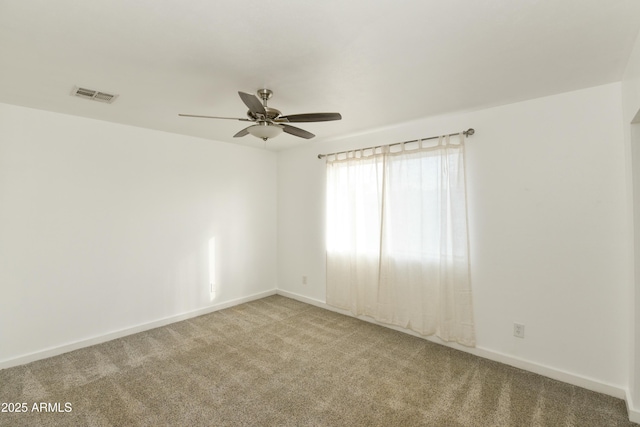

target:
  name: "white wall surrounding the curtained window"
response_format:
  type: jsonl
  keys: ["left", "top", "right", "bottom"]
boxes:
{"left": 278, "top": 84, "right": 631, "bottom": 390}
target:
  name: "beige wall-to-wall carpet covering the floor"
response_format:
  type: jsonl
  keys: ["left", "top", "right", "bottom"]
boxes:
{"left": 0, "top": 296, "right": 634, "bottom": 427}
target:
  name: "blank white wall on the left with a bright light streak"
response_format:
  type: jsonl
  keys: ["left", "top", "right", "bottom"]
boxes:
{"left": 0, "top": 104, "right": 277, "bottom": 364}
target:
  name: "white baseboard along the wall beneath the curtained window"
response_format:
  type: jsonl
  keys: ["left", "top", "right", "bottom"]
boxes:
{"left": 277, "top": 289, "right": 624, "bottom": 402}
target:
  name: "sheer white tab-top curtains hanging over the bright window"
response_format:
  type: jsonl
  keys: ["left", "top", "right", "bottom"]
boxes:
{"left": 327, "top": 135, "right": 475, "bottom": 346}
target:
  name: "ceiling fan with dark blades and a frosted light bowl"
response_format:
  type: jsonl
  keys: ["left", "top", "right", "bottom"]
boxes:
{"left": 178, "top": 89, "right": 342, "bottom": 141}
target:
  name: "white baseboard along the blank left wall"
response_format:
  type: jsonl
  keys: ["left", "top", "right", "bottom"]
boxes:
{"left": 0, "top": 289, "right": 276, "bottom": 369}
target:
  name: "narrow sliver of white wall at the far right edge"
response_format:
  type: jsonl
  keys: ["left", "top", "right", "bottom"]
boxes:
{"left": 622, "top": 25, "right": 640, "bottom": 422}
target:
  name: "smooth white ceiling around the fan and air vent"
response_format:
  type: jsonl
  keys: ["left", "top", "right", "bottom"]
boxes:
{"left": 0, "top": 0, "right": 640, "bottom": 150}
